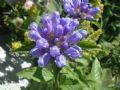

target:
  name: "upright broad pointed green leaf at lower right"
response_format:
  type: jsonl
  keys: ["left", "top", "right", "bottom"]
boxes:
{"left": 88, "top": 58, "right": 113, "bottom": 90}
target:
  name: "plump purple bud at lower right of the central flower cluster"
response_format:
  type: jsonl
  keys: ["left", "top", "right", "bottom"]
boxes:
{"left": 65, "top": 47, "right": 81, "bottom": 60}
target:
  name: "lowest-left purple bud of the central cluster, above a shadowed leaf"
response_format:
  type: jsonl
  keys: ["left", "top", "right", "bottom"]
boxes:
{"left": 38, "top": 53, "right": 51, "bottom": 67}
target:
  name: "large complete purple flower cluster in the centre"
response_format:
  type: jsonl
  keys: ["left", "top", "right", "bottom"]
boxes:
{"left": 29, "top": 11, "right": 87, "bottom": 68}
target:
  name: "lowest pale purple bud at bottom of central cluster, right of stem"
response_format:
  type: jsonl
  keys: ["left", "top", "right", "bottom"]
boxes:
{"left": 55, "top": 55, "right": 66, "bottom": 68}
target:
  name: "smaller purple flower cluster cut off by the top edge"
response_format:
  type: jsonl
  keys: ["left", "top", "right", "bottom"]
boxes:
{"left": 63, "top": 0, "right": 100, "bottom": 20}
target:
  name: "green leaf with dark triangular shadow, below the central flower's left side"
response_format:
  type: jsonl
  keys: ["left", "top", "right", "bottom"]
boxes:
{"left": 17, "top": 67, "right": 53, "bottom": 82}
